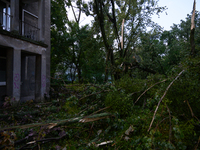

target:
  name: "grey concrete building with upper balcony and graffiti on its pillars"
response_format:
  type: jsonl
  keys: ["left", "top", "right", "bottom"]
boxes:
{"left": 0, "top": 0, "right": 50, "bottom": 104}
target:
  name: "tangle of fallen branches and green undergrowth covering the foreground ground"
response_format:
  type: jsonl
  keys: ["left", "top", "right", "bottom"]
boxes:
{"left": 1, "top": 62, "right": 200, "bottom": 150}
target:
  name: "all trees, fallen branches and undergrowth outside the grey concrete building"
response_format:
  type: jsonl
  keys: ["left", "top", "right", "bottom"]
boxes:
{"left": 0, "top": 0, "right": 200, "bottom": 150}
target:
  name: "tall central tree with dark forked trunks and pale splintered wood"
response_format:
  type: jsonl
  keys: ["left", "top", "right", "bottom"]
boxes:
{"left": 85, "top": 0, "right": 164, "bottom": 81}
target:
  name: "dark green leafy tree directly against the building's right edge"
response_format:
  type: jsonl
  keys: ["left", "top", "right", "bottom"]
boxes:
{"left": 51, "top": 0, "right": 68, "bottom": 77}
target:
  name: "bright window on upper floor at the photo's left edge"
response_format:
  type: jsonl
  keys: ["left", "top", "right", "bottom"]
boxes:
{"left": 0, "top": 0, "right": 11, "bottom": 31}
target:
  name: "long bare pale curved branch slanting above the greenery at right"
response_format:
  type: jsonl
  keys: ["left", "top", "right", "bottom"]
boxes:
{"left": 148, "top": 70, "right": 185, "bottom": 132}
